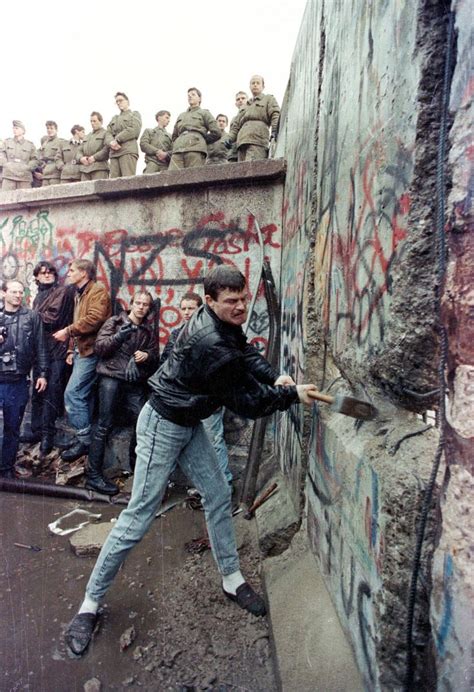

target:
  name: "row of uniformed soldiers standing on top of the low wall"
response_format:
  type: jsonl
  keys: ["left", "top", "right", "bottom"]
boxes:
{"left": 0, "top": 75, "right": 280, "bottom": 190}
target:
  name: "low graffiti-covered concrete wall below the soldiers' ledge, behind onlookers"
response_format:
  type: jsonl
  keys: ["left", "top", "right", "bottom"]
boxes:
{"left": 0, "top": 187, "right": 281, "bottom": 350}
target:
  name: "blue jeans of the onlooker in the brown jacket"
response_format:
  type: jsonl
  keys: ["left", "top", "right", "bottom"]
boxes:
{"left": 64, "top": 350, "right": 98, "bottom": 445}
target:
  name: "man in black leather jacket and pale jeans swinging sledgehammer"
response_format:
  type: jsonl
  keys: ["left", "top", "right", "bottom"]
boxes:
{"left": 66, "top": 265, "right": 316, "bottom": 655}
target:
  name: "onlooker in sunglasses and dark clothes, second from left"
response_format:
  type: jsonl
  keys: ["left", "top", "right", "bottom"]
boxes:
{"left": 20, "top": 260, "right": 74, "bottom": 456}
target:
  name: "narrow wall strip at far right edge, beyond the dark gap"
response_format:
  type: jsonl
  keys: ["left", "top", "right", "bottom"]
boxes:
{"left": 430, "top": 0, "right": 474, "bottom": 692}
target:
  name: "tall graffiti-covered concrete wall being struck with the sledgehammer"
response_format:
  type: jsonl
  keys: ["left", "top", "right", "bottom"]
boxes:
{"left": 277, "top": 0, "right": 467, "bottom": 689}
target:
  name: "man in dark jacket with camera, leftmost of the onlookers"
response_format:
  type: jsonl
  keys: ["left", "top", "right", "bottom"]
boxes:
{"left": 0, "top": 279, "right": 49, "bottom": 478}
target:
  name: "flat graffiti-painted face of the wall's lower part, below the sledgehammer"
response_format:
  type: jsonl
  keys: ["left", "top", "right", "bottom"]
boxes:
{"left": 308, "top": 409, "right": 385, "bottom": 686}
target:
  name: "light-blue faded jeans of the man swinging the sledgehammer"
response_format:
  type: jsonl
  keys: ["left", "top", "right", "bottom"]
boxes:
{"left": 86, "top": 403, "right": 239, "bottom": 601}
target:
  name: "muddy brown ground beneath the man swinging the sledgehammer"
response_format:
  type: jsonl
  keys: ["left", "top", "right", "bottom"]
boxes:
{"left": 0, "top": 492, "right": 277, "bottom": 692}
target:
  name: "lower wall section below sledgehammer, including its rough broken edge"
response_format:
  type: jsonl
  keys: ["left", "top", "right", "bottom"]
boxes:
{"left": 307, "top": 412, "right": 437, "bottom": 690}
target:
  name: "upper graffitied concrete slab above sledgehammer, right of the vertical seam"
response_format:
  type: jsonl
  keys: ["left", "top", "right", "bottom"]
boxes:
{"left": 313, "top": 2, "right": 452, "bottom": 410}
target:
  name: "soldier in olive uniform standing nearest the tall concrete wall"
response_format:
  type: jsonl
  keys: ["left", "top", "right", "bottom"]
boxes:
{"left": 227, "top": 75, "right": 280, "bottom": 161}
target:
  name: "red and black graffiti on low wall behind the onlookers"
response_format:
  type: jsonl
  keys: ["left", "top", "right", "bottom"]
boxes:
{"left": 0, "top": 204, "right": 280, "bottom": 350}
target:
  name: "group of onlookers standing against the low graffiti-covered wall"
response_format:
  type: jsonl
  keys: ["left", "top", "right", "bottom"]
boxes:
{"left": 0, "top": 259, "right": 232, "bottom": 495}
